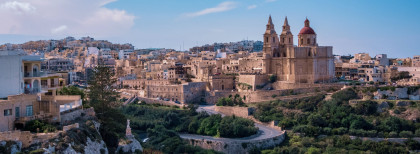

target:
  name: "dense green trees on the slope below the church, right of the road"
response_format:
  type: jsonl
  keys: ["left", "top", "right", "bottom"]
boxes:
{"left": 254, "top": 88, "right": 420, "bottom": 137}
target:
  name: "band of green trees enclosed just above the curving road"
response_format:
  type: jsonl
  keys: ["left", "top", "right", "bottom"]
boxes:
{"left": 122, "top": 104, "right": 258, "bottom": 138}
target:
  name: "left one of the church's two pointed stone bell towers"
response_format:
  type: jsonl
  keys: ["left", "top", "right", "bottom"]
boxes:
{"left": 263, "top": 15, "right": 279, "bottom": 57}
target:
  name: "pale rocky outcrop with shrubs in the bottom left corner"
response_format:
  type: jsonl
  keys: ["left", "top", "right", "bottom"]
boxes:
{"left": 0, "top": 120, "right": 110, "bottom": 154}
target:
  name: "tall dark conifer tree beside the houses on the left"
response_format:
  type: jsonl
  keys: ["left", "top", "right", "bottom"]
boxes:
{"left": 88, "top": 64, "right": 126, "bottom": 151}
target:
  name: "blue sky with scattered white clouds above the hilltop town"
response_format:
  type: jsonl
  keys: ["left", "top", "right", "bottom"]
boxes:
{"left": 0, "top": 0, "right": 420, "bottom": 58}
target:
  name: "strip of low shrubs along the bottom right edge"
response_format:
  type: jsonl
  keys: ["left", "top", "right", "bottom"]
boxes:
{"left": 261, "top": 134, "right": 420, "bottom": 154}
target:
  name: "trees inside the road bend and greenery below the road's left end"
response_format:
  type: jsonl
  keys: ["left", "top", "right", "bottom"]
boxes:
{"left": 121, "top": 104, "right": 258, "bottom": 153}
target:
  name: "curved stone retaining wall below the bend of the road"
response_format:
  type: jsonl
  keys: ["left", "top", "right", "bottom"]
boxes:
{"left": 185, "top": 132, "right": 286, "bottom": 154}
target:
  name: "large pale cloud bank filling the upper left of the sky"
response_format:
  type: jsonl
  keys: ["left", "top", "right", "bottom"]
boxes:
{"left": 0, "top": 0, "right": 136, "bottom": 37}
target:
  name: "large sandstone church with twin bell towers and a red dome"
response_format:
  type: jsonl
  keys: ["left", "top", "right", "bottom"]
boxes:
{"left": 262, "top": 16, "right": 335, "bottom": 83}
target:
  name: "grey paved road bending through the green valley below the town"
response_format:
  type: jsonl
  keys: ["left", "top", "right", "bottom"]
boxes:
{"left": 179, "top": 105, "right": 282, "bottom": 142}
